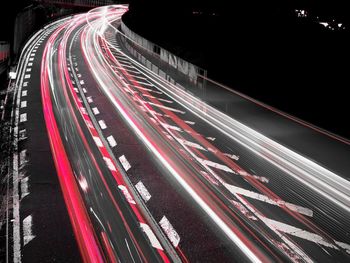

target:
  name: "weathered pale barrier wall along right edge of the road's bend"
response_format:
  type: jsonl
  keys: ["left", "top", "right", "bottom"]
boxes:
{"left": 121, "top": 21, "right": 206, "bottom": 84}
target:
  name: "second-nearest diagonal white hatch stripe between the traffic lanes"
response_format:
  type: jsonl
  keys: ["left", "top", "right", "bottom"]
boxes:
{"left": 223, "top": 182, "right": 313, "bottom": 217}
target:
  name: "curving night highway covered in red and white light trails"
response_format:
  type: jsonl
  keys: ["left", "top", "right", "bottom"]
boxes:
{"left": 8, "top": 5, "right": 350, "bottom": 262}
